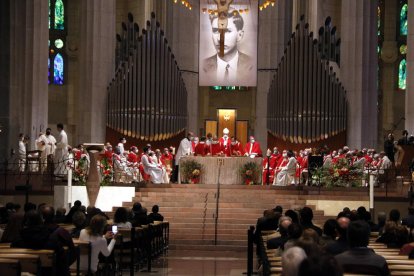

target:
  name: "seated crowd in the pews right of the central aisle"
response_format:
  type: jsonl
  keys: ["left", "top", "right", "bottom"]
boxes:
{"left": 254, "top": 206, "right": 414, "bottom": 276}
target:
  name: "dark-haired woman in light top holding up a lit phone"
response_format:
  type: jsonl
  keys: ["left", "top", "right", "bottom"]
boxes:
{"left": 79, "top": 215, "right": 117, "bottom": 273}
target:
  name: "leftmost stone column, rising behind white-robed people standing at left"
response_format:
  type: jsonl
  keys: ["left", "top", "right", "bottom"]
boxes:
{"left": 7, "top": 0, "right": 49, "bottom": 150}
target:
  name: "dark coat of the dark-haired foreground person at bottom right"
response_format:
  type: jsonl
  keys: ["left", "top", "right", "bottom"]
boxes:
{"left": 335, "top": 247, "right": 390, "bottom": 276}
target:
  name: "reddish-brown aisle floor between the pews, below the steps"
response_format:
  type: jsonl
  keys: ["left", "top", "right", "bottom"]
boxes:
{"left": 136, "top": 250, "right": 251, "bottom": 276}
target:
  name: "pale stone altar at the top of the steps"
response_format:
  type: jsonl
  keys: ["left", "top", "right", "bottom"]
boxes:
{"left": 179, "top": 156, "right": 263, "bottom": 185}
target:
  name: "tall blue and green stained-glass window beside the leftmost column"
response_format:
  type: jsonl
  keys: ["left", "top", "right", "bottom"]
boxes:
{"left": 48, "top": 0, "right": 67, "bottom": 85}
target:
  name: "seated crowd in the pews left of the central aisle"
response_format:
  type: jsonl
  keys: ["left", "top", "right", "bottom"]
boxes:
{"left": 0, "top": 198, "right": 164, "bottom": 275}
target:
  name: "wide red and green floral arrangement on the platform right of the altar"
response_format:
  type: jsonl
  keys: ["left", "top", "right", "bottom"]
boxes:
{"left": 312, "top": 158, "right": 363, "bottom": 187}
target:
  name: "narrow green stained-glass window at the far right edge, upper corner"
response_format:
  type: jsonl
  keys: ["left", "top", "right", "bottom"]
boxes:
{"left": 397, "top": 0, "right": 408, "bottom": 91}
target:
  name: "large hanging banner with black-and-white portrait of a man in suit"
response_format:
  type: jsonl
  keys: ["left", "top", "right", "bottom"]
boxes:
{"left": 199, "top": 0, "right": 258, "bottom": 86}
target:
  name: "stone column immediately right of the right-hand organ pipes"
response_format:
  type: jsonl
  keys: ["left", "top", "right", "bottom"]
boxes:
{"left": 341, "top": 0, "right": 378, "bottom": 148}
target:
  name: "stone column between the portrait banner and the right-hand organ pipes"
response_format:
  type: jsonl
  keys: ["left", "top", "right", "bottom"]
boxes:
{"left": 254, "top": 0, "right": 292, "bottom": 152}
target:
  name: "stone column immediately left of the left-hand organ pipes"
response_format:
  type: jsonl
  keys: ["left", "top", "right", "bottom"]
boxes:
{"left": 75, "top": 0, "right": 116, "bottom": 143}
